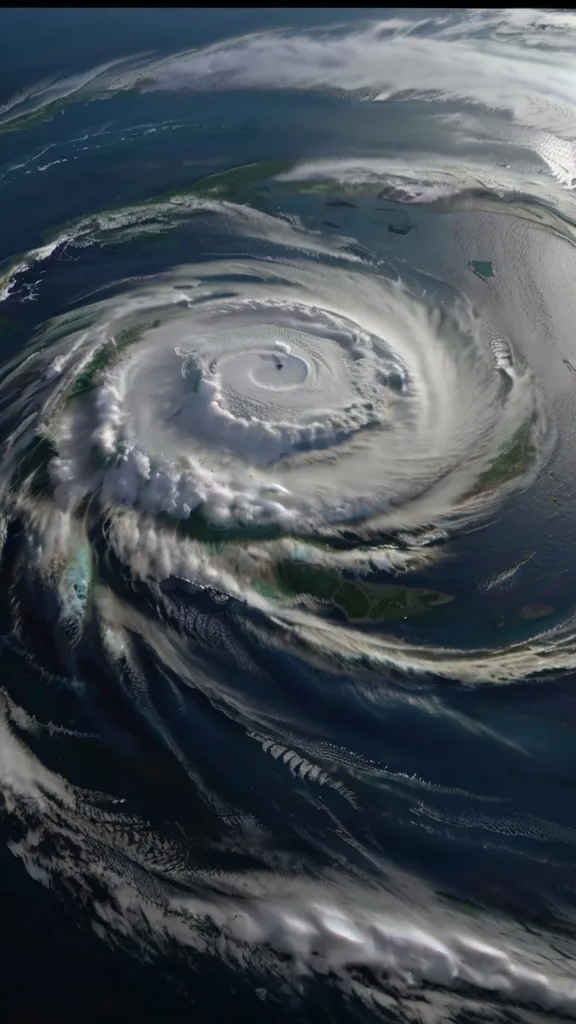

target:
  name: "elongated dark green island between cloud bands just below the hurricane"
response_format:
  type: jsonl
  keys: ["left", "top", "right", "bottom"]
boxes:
{"left": 256, "top": 559, "right": 454, "bottom": 623}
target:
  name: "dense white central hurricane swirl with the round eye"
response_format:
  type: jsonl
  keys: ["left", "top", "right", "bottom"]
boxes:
{"left": 25, "top": 203, "right": 536, "bottom": 532}
